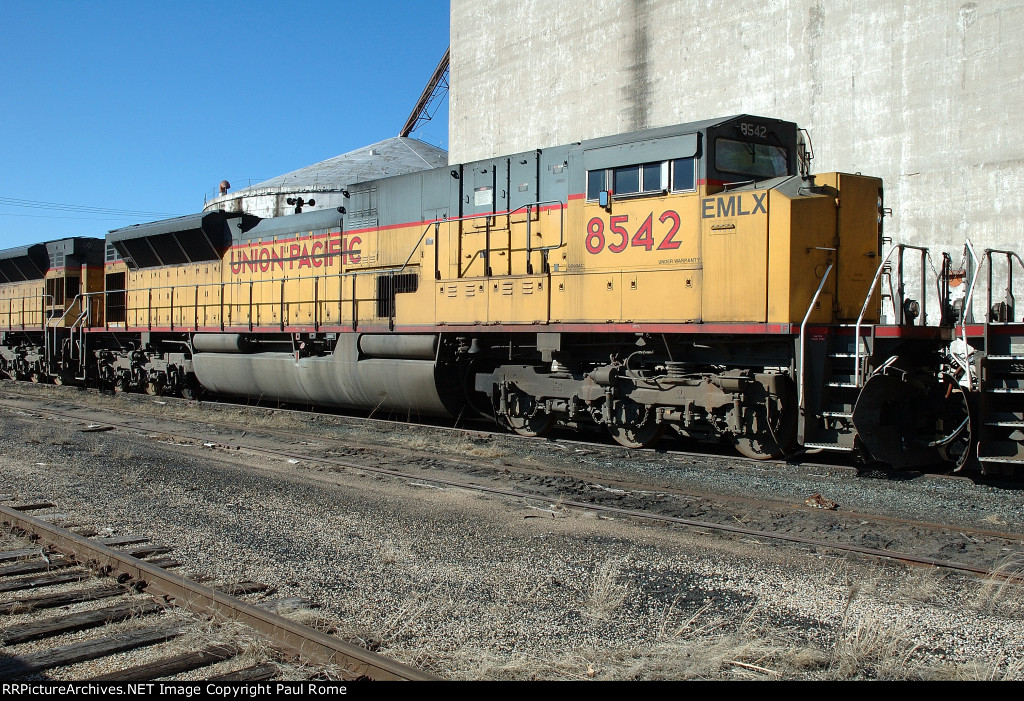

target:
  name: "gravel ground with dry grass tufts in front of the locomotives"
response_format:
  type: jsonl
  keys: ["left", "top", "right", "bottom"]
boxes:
{"left": 0, "top": 388, "right": 1024, "bottom": 680}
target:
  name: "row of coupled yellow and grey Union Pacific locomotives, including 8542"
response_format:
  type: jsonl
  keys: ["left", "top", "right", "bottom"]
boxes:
{"left": 0, "top": 115, "right": 1024, "bottom": 472}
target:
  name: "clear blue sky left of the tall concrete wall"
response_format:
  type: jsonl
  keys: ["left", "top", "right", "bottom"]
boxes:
{"left": 0, "top": 0, "right": 449, "bottom": 249}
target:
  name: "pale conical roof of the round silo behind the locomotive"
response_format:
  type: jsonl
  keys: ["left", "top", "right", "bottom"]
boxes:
{"left": 232, "top": 136, "right": 447, "bottom": 200}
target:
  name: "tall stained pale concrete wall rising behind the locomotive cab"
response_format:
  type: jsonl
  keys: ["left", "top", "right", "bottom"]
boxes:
{"left": 450, "top": 0, "right": 1024, "bottom": 260}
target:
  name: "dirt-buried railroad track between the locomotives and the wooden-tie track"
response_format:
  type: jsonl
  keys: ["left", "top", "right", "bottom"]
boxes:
{"left": 4, "top": 388, "right": 1024, "bottom": 580}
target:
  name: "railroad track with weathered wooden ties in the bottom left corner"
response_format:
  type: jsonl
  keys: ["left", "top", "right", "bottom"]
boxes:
{"left": 0, "top": 496, "right": 433, "bottom": 682}
